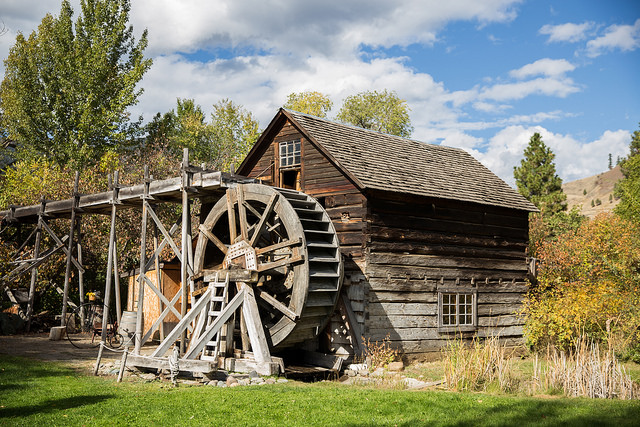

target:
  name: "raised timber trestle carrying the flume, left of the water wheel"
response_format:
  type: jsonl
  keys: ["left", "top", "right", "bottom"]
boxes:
{"left": 0, "top": 149, "right": 268, "bottom": 370}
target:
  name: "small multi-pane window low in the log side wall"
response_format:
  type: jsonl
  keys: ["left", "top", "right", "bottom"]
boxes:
{"left": 438, "top": 291, "right": 476, "bottom": 331}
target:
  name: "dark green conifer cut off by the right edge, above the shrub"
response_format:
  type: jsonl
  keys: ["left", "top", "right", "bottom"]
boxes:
{"left": 614, "top": 122, "right": 640, "bottom": 224}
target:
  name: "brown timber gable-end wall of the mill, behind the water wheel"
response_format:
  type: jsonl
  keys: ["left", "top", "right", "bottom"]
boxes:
{"left": 242, "top": 118, "right": 367, "bottom": 355}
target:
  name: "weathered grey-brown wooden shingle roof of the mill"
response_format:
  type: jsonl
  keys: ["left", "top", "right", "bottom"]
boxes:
{"left": 240, "top": 110, "right": 538, "bottom": 211}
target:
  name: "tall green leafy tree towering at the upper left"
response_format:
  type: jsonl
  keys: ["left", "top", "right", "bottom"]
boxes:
{"left": 0, "top": 0, "right": 151, "bottom": 168}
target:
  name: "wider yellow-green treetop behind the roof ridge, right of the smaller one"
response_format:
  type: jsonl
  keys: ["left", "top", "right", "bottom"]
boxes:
{"left": 337, "top": 89, "right": 413, "bottom": 137}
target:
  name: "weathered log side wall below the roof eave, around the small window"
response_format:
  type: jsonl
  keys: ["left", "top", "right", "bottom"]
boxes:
{"left": 365, "top": 192, "right": 528, "bottom": 358}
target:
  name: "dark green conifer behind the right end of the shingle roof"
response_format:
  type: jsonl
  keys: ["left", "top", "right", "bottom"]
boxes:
{"left": 513, "top": 132, "right": 567, "bottom": 215}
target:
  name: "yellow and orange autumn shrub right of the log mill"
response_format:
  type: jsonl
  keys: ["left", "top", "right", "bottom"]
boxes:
{"left": 524, "top": 214, "right": 640, "bottom": 354}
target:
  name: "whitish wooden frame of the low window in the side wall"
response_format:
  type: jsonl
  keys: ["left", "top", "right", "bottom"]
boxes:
{"left": 438, "top": 288, "right": 478, "bottom": 332}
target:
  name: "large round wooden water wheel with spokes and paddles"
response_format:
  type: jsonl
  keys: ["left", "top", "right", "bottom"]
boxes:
{"left": 194, "top": 184, "right": 342, "bottom": 348}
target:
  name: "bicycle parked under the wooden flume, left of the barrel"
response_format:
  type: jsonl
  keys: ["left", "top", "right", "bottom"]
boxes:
{"left": 66, "top": 301, "right": 124, "bottom": 348}
